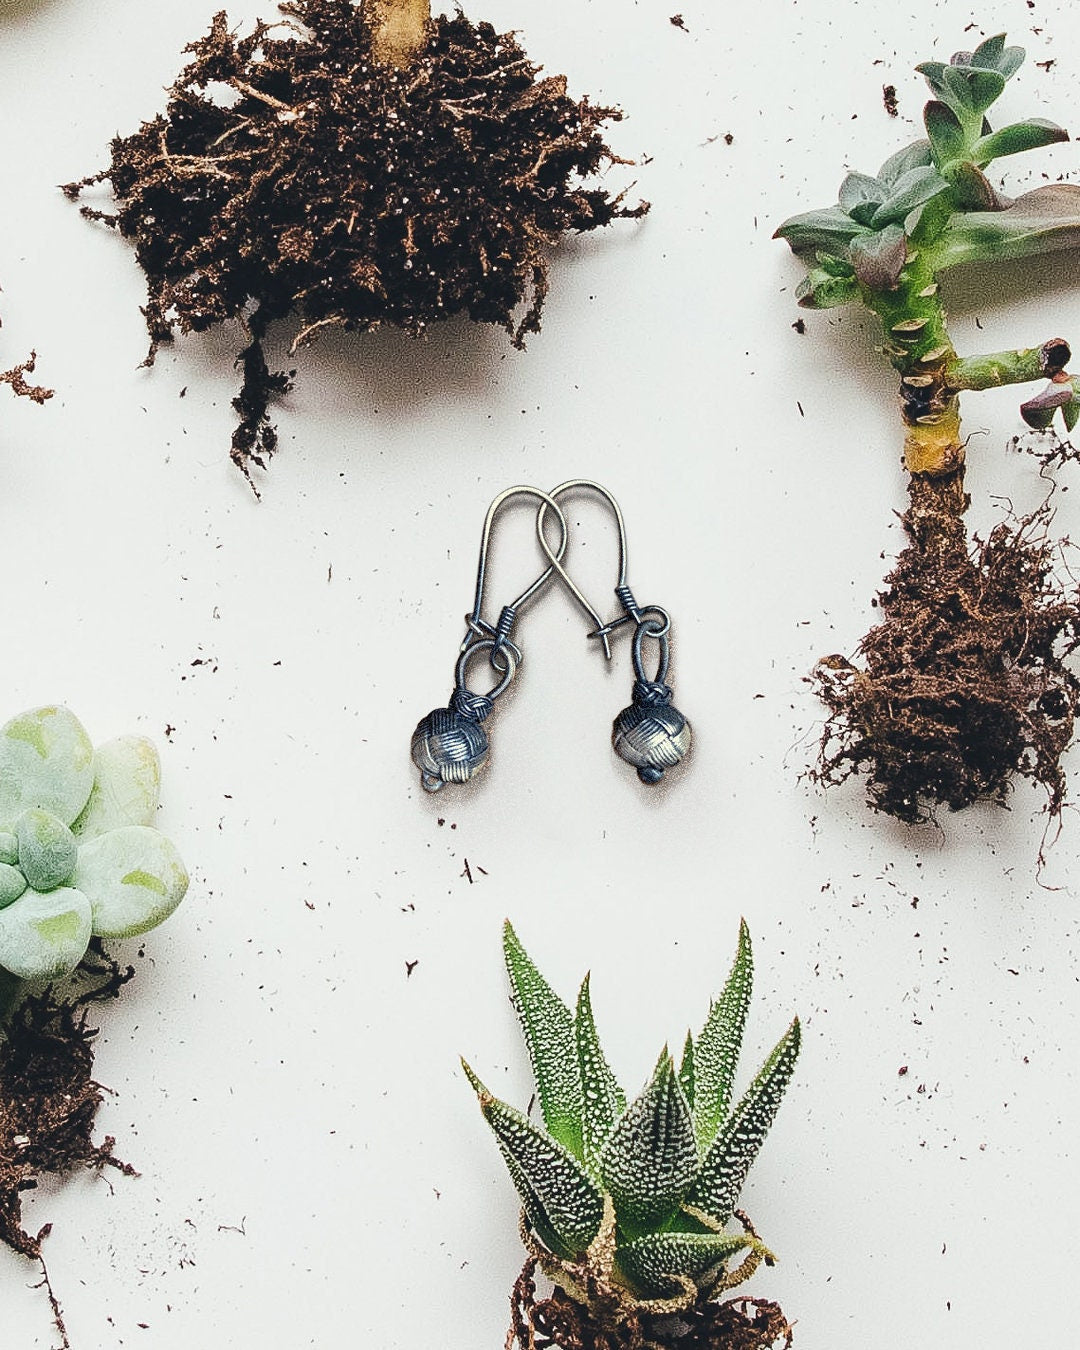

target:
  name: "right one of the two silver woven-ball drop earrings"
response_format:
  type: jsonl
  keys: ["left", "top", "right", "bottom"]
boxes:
{"left": 536, "top": 478, "right": 691, "bottom": 783}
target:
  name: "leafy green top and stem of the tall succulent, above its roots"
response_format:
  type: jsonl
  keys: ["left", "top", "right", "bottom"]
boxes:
{"left": 776, "top": 34, "right": 1080, "bottom": 474}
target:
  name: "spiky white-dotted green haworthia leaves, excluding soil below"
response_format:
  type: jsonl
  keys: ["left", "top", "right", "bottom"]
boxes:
{"left": 464, "top": 923, "right": 799, "bottom": 1300}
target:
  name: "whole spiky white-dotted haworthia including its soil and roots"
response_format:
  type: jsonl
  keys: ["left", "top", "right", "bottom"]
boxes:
{"left": 463, "top": 923, "right": 801, "bottom": 1350}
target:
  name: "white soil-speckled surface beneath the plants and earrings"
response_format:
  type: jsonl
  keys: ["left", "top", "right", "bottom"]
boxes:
{"left": 0, "top": 0, "right": 1080, "bottom": 1350}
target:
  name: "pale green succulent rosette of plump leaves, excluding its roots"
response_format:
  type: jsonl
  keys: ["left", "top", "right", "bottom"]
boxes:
{"left": 0, "top": 707, "right": 188, "bottom": 980}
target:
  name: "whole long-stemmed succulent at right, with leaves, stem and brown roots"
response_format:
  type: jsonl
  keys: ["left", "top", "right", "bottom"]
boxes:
{"left": 776, "top": 35, "right": 1080, "bottom": 822}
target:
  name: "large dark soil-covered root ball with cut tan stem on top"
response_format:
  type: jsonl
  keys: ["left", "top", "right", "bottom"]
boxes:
{"left": 65, "top": 0, "right": 648, "bottom": 478}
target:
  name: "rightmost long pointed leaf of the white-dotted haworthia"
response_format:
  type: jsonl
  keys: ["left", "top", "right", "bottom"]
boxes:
{"left": 687, "top": 1018, "right": 801, "bottom": 1224}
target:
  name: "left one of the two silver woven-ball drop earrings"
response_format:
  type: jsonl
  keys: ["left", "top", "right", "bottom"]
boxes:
{"left": 412, "top": 486, "right": 567, "bottom": 792}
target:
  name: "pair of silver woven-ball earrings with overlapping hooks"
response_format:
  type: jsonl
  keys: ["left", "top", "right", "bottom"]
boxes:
{"left": 412, "top": 478, "right": 691, "bottom": 792}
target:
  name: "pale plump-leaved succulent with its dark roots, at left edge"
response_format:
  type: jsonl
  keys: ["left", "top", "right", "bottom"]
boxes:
{"left": 0, "top": 706, "right": 188, "bottom": 1345}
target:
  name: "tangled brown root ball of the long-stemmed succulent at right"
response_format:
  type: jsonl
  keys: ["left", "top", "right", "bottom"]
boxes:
{"left": 813, "top": 474, "right": 1080, "bottom": 824}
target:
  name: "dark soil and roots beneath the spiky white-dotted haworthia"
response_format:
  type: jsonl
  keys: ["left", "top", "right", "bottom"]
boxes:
{"left": 506, "top": 1257, "right": 792, "bottom": 1350}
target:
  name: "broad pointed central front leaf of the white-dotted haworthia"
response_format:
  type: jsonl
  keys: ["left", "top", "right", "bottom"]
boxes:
{"left": 601, "top": 1050, "right": 698, "bottom": 1237}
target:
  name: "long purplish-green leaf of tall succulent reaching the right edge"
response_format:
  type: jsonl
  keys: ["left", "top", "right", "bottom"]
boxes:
{"left": 936, "top": 182, "right": 1080, "bottom": 271}
